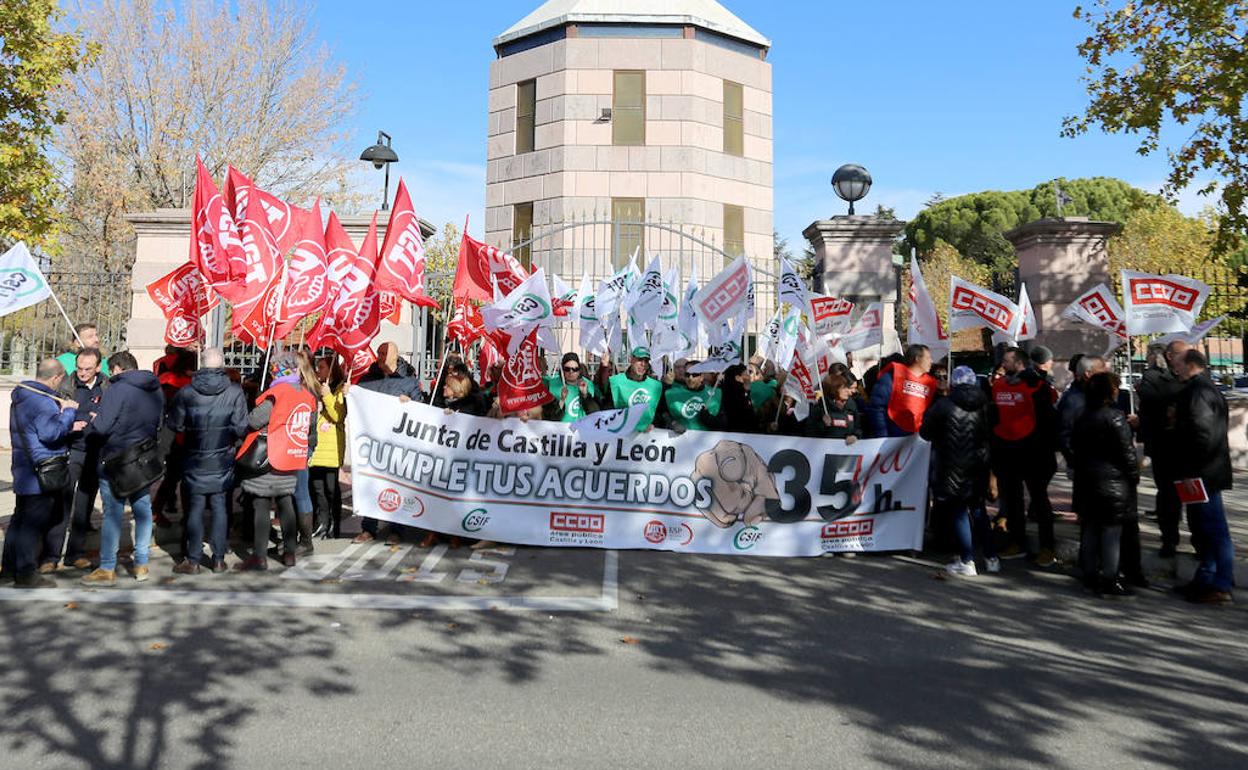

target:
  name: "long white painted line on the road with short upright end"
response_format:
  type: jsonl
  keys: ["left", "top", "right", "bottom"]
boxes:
{"left": 0, "top": 550, "right": 619, "bottom": 613}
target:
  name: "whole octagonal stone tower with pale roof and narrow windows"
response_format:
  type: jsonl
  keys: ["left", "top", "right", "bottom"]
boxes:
{"left": 485, "top": 0, "right": 773, "bottom": 321}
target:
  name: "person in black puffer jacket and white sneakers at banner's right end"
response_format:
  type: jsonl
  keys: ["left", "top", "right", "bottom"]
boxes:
{"left": 919, "top": 367, "right": 1001, "bottom": 577}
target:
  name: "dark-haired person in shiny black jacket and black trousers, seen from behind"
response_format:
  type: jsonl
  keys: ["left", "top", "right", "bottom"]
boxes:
{"left": 1071, "top": 372, "right": 1139, "bottom": 597}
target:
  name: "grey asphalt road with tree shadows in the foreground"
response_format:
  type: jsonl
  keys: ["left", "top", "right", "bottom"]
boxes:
{"left": 0, "top": 459, "right": 1248, "bottom": 770}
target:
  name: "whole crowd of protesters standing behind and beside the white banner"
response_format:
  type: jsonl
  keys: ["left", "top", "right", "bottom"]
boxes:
{"left": 0, "top": 324, "right": 1234, "bottom": 604}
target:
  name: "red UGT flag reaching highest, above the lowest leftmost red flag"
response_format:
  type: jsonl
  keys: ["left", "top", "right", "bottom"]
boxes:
{"left": 190, "top": 157, "right": 247, "bottom": 302}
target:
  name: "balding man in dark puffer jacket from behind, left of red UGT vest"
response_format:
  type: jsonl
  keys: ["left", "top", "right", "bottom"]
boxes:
{"left": 170, "top": 348, "right": 247, "bottom": 575}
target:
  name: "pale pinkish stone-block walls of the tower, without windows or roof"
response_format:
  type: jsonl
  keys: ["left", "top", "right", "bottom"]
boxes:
{"left": 485, "top": 24, "right": 774, "bottom": 314}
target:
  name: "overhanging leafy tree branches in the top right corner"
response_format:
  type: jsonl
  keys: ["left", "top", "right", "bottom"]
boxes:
{"left": 1062, "top": 0, "right": 1248, "bottom": 252}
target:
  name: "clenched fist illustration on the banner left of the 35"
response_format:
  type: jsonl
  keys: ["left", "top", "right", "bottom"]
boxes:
{"left": 693, "top": 441, "right": 780, "bottom": 529}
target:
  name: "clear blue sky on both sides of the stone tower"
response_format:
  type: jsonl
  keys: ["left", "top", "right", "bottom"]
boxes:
{"left": 316, "top": 0, "right": 1203, "bottom": 245}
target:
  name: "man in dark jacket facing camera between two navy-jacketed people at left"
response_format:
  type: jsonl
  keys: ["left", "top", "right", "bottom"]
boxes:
{"left": 50, "top": 348, "right": 109, "bottom": 573}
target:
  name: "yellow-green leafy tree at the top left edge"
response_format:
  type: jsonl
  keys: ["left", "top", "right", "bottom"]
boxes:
{"left": 0, "top": 0, "right": 90, "bottom": 246}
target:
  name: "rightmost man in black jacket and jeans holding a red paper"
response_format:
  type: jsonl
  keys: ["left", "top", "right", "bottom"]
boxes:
{"left": 1174, "top": 349, "right": 1236, "bottom": 604}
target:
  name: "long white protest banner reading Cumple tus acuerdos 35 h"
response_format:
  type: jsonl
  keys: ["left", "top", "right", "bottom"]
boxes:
{"left": 347, "top": 388, "right": 930, "bottom": 557}
